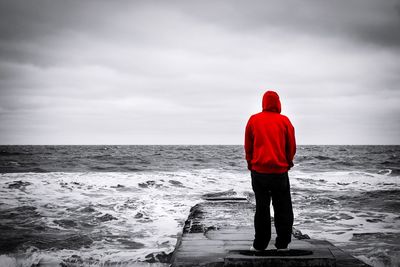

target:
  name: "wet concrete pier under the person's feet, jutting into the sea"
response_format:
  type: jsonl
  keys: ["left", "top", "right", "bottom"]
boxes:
{"left": 172, "top": 197, "right": 369, "bottom": 267}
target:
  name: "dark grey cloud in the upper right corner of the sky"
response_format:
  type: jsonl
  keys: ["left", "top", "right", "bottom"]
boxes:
{"left": 173, "top": 0, "right": 400, "bottom": 49}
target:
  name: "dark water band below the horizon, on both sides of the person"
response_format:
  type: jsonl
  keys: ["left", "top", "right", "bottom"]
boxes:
{"left": 0, "top": 146, "right": 400, "bottom": 175}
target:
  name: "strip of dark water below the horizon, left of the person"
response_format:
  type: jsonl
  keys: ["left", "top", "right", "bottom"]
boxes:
{"left": 0, "top": 146, "right": 244, "bottom": 173}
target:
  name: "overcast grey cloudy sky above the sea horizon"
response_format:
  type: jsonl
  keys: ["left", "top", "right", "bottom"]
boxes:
{"left": 0, "top": 0, "right": 400, "bottom": 144}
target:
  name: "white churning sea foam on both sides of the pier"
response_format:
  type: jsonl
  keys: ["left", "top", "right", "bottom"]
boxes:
{"left": 0, "top": 169, "right": 400, "bottom": 266}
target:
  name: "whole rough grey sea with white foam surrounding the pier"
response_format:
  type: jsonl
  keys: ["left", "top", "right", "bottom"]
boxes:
{"left": 0, "top": 146, "right": 400, "bottom": 266}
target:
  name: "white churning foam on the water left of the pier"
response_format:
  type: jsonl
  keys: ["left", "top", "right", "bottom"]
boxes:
{"left": 0, "top": 170, "right": 247, "bottom": 262}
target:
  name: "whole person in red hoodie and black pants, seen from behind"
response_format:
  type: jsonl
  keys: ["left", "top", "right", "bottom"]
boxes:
{"left": 244, "top": 91, "right": 296, "bottom": 250}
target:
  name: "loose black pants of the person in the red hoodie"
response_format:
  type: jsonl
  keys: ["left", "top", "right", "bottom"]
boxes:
{"left": 251, "top": 171, "right": 293, "bottom": 250}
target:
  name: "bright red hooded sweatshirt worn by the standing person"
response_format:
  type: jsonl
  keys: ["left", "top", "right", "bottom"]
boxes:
{"left": 244, "top": 91, "right": 296, "bottom": 173}
